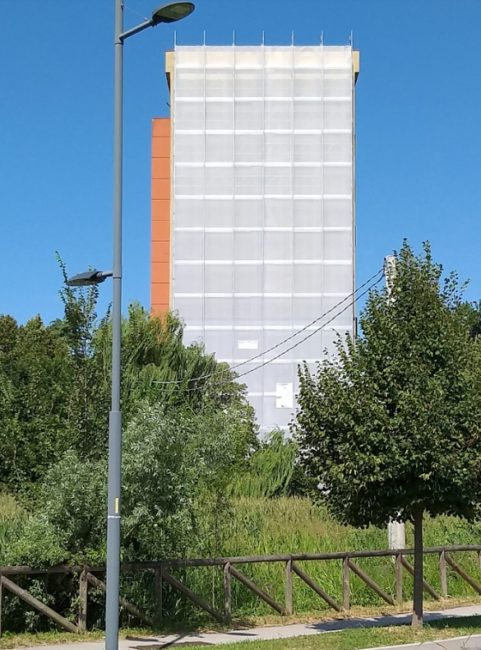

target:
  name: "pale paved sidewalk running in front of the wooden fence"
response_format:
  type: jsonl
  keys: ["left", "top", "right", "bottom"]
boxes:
{"left": 12, "top": 605, "right": 481, "bottom": 650}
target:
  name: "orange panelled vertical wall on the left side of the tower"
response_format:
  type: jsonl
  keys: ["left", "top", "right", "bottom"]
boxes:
{"left": 150, "top": 117, "right": 171, "bottom": 315}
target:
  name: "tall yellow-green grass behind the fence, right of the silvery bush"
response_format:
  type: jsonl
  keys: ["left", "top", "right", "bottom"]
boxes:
{"left": 177, "top": 497, "right": 481, "bottom": 616}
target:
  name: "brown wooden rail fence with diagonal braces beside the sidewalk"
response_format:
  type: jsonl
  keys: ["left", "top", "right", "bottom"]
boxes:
{"left": 0, "top": 545, "right": 481, "bottom": 635}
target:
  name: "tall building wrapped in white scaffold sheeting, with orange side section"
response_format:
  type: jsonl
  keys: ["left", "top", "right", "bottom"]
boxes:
{"left": 151, "top": 45, "right": 358, "bottom": 431}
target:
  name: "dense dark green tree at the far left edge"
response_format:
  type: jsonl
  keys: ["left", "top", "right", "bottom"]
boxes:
{"left": 0, "top": 316, "right": 70, "bottom": 488}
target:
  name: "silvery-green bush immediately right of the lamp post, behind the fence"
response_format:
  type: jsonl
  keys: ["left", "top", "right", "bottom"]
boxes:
{"left": 123, "top": 404, "right": 253, "bottom": 560}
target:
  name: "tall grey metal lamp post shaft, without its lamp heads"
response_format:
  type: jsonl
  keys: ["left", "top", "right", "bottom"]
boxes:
{"left": 105, "top": 0, "right": 123, "bottom": 650}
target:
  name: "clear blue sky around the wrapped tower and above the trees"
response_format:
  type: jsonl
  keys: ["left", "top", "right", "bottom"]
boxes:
{"left": 0, "top": 0, "right": 481, "bottom": 322}
